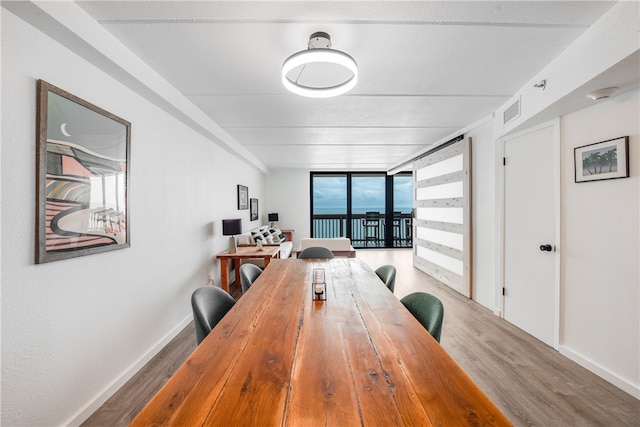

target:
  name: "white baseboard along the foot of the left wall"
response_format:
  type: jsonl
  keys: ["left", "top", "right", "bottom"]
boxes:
{"left": 64, "top": 315, "right": 193, "bottom": 426}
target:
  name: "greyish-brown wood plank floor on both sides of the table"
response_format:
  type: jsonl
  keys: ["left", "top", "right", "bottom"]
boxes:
{"left": 83, "top": 250, "right": 640, "bottom": 427}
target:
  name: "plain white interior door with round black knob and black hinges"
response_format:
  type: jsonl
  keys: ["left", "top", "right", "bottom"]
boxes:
{"left": 503, "top": 124, "right": 558, "bottom": 347}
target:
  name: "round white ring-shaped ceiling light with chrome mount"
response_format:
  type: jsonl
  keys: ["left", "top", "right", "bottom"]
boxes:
{"left": 282, "top": 32, "right": 358, "bottom": 98}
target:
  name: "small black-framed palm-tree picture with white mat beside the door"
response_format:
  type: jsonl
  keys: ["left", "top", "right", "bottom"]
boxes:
{"left": 574, "top": 136, "right": 629, "bottom": 182}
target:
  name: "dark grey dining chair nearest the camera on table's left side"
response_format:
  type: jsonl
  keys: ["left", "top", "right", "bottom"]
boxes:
{"left": 191, "top": 286, "right": 236, "bottom": 345}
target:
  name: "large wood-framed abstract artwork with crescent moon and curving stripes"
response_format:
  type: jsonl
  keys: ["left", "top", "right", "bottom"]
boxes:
{"left": 36, "top": 80, "right": 131, "bottom": 263}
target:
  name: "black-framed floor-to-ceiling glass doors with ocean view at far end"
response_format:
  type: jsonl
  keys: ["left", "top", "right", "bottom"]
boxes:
{"left": 311, "top": 172, "right": 413, "bottom": 248}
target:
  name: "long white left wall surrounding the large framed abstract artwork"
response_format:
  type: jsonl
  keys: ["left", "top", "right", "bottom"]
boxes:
{"left": 0, "top": 10, "right": 265, "bottom": 426}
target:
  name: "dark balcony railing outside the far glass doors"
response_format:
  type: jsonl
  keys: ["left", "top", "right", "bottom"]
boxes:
{"left": 313, "top": 213, "right": 413, "bottom": 248}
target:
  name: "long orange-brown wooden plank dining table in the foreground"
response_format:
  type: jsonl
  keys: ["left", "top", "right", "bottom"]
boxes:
{"left": 131, "top": 258, "right": 512, "bottom": 427}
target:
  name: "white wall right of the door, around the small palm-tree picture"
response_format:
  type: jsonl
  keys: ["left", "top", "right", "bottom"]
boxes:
{"left": 560, "top": 90, "right": 640, "bottom": 398}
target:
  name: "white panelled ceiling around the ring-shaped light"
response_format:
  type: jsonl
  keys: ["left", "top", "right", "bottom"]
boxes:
{"left": 72, "top": 1, "right": 614, "bottom": 170}
